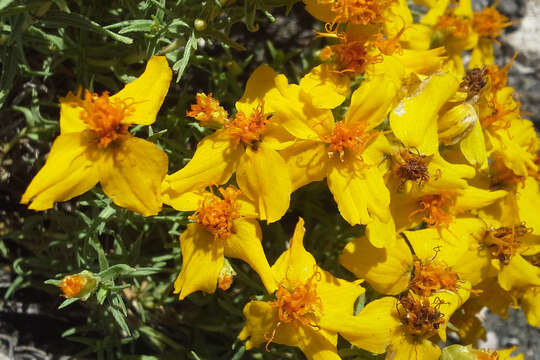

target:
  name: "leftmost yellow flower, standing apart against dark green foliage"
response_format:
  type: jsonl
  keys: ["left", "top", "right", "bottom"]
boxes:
{"left": 21, "top": 56, "right": 172, "bottom": 216}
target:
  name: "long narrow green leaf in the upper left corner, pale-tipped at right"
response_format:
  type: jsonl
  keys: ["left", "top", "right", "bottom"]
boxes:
{"left": 40, "top": 11, "right": 133, "bottom": 44}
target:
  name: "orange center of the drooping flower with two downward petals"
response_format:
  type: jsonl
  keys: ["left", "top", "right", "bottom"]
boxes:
{"left": 189, "top": 186, "right": 241, "bottom": 240}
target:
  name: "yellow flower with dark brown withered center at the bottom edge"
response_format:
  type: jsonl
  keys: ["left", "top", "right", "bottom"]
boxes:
{"left": 324, "top": 289, "right": 469, "bottom": 360}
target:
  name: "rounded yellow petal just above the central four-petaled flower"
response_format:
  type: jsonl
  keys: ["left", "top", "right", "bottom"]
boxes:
{"left": 300, "top": 63, "right": 351, "bottom": 109}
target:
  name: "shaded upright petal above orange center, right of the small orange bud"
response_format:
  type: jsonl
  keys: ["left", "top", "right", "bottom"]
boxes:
{"left": 236, "top": 65, "right": 278, "bottom": 116}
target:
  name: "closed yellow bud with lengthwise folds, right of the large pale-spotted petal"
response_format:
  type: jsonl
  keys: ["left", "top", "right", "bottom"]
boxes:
{"left": 439, "top": 103, "right": 478, "bottom": 145}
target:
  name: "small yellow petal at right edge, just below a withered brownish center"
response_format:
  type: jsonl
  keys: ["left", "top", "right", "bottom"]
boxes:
{"left": 499, "top": 255, "right": 540, "bottom": 291}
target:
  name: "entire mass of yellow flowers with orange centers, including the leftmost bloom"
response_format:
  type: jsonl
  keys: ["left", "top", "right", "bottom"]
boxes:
{"left": 21, "top": 0, "right": 540, "bottom": 360}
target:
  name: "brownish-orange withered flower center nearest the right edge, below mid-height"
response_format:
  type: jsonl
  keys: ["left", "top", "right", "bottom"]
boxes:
{"left": 484, "top": 224, "right": 532, "bottom": 265}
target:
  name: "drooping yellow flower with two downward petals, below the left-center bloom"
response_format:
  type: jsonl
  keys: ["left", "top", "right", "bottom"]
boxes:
{"left": 174, "top": 186, "right": 276, "bottom": 300}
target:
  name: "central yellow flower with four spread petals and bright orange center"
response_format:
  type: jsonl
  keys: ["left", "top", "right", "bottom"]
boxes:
{"left": 267, "top": 70, "right": 399, "bottom": 233}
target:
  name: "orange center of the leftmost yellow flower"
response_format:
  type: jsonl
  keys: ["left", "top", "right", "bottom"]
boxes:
{"left": 63, "top": 90, "right": 135, "bottom": 147}
